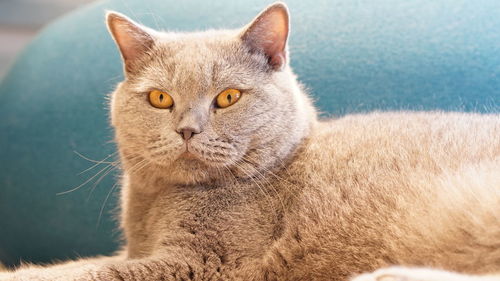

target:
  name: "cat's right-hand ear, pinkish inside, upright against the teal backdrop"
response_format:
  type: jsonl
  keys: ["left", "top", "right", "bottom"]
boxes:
{"left": 241, "top": 2, "right": 290, "bottom": 70}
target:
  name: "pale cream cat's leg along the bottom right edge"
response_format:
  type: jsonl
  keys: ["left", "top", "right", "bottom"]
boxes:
{"left": 352, "top": 267, "right": 500, "bottom": 281}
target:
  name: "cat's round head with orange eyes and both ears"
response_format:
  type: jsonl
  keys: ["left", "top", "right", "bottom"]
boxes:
{"left": 107, "top": 3, "right": 316, "bottom": 184}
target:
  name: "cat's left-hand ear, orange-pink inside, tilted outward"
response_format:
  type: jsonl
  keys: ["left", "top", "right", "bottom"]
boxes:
{"left": 106, "top": 12, "right": 154, "bottom": 71}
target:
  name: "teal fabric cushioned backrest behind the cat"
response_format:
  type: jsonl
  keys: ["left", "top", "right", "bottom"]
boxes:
{"left": 0, "top": 0, "right": 500, "bottom": 265}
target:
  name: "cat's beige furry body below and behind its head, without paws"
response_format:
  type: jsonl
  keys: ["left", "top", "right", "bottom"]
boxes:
{"left": 121, "top": 112, "right": 500, "bottom": 280}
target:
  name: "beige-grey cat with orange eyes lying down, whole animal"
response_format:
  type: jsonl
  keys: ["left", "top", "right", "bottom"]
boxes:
{"left": 0, "top": 2, "right": 500, "bottom": 281}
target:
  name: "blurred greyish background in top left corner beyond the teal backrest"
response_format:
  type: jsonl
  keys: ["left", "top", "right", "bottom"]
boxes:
{"left": 0, "top": 0, "right": 94, "bottom": 77}
